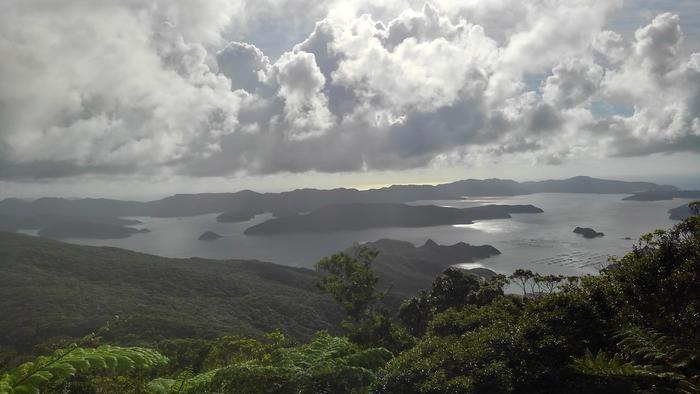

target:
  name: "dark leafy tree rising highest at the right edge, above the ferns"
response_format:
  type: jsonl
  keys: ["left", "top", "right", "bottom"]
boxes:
{"left": 596, "top": 217, "right": 700, "bottom": 342}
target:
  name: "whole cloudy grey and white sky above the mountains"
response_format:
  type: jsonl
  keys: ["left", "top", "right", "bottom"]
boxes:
{"left": 0, "top": 0, "right": 700, "bottom": 199}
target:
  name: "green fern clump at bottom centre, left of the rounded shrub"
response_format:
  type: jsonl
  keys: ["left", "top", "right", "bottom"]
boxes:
{"left": 148, "top": 332, "right": 392, "bottom": 394}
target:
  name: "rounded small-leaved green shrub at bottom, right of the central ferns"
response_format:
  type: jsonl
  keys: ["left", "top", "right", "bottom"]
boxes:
{"left": 376, "top": 300, "right": 521, "bottom": 393}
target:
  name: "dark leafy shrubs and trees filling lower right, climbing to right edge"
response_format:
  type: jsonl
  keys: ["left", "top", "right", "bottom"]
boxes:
{"left": 376, "top": 218, "right": 700, "bottom": 393}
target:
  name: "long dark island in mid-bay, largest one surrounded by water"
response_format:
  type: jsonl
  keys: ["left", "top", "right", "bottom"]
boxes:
{"left": 245, "top": 203, "right": 542, "bottom": 235}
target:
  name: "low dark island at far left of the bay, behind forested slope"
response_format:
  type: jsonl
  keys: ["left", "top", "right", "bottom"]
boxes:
{"left": 39, "top": 220, "right": 150, "bottom": 239}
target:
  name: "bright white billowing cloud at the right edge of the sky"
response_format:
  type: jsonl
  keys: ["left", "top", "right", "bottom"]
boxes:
{"left": 594, "top": 14, "right": 700, "bottom": 156}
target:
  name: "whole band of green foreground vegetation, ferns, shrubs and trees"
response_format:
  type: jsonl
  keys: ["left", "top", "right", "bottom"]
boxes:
{"left": 0, "top": 208, "right": 700, "bottom": 393}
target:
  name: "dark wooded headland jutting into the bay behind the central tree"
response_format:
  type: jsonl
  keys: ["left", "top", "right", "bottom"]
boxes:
{"left": 347, "top": 239, "right": 501, "bottom": 302}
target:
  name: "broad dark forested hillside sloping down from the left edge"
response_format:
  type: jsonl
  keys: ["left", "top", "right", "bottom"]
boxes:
{"left": 0, "top": 232, "right": 342, "bottom": 347}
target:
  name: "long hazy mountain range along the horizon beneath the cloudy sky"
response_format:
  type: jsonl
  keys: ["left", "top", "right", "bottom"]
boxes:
{"left": 0, "top": 176, "right": 677, "bottom": 235}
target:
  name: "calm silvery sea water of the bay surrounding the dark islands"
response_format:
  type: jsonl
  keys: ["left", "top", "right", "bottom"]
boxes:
{"left": 24, "top": 193, "right": 688, "bottom": 274}
